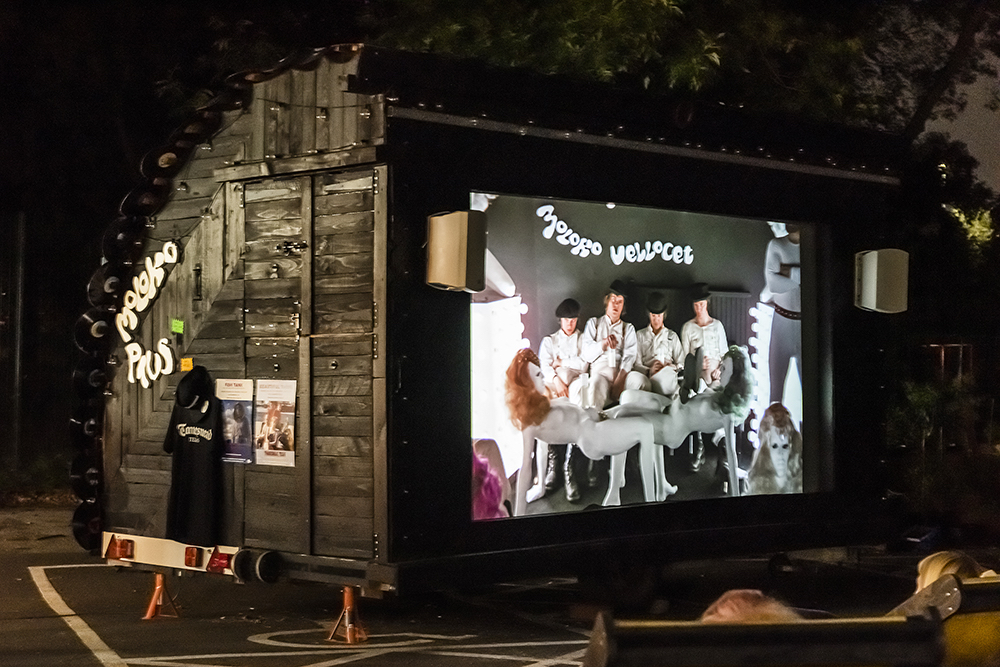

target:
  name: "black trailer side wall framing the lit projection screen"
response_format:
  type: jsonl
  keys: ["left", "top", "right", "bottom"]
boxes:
{"left": 380, "top": 115, "right": 896, "bottom": 561}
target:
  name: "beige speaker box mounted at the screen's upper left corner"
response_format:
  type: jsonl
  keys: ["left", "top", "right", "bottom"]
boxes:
{"left": 427, "top": 211, "right": 486, "bottom": 292}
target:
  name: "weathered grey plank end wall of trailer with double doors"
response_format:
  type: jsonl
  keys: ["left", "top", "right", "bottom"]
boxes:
{"left": 104, "top": 53, "right": 386, "bottom": 558}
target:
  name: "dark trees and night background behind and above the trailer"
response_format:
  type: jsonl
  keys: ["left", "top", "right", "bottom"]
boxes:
{"left": 0, "top": 0, "right": 1000, "bottom": 474}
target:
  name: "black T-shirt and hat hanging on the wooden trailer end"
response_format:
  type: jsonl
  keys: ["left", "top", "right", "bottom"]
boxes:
{"left": 163, "top": 366, "right": 224, "bottom": 547}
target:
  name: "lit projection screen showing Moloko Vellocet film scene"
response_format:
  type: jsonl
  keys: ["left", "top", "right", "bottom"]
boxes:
{"left": 470, "top": 192, "right": 822, "bottom": 520}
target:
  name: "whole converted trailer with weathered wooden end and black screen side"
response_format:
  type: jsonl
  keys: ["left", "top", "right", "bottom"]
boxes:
{"left": 74, "top": 45, "right": 905, "bottom": 595}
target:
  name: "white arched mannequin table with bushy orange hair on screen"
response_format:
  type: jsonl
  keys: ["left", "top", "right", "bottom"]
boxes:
{"left": 506, "top": 349, "right": 664, "bottom": 516}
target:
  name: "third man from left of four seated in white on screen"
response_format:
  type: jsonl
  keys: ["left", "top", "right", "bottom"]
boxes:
{"left": 625, "top": 292, "right": 684, "bottom": 397}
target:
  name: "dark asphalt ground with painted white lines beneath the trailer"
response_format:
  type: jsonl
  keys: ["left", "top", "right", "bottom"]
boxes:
{"left": 0, "top": 506, "right": 1000, "bottom": 667}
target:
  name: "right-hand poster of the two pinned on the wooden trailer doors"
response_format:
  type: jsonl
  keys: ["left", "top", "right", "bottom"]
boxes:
{"left": 254, "top": 380, "right": 296, "bottom": 466}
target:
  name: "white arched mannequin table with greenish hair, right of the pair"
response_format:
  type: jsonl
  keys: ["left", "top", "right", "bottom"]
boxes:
{"left": 606, "top": 345, "right": 753, "bottom": 496}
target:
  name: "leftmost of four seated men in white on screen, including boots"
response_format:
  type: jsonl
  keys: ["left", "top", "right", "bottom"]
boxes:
{"left": 538, "top": 299, "right": 590, "bottom": 502}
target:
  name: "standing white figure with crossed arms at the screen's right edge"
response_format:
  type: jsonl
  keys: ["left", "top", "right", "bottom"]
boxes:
{"left": 760, "top": 222, "right": 802, "bottom": 423}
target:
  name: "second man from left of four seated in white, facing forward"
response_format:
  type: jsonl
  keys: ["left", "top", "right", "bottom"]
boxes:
{"left": 582, "top": 280, "right": 639, "bottom": 410}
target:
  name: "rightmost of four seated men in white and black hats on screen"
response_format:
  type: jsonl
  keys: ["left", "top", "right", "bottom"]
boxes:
{"left": 681, "top": 283, "right": 729, "bottom": 472}
